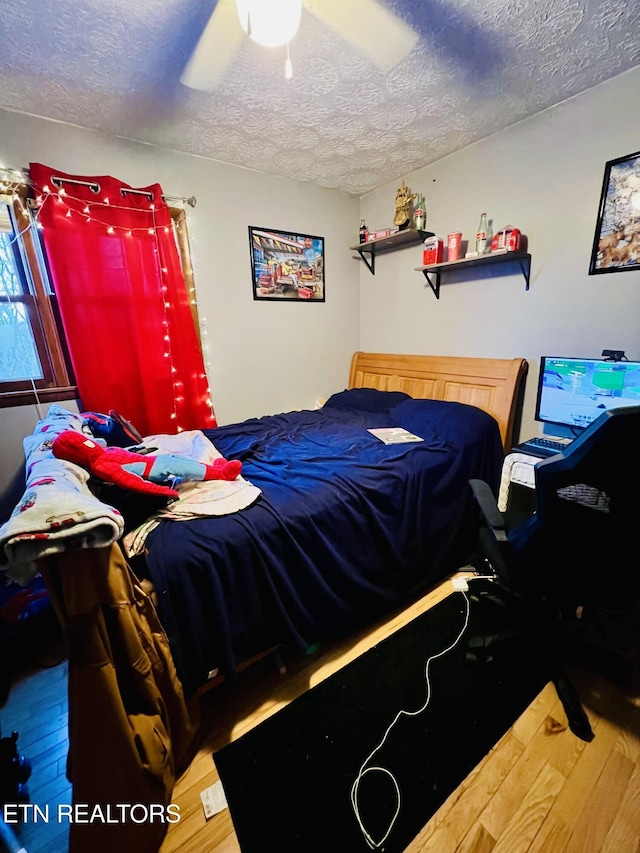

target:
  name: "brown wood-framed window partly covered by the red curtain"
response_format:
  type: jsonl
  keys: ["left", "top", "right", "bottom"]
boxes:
{"left": 0, "top": 185, "right": 199, "bottom": 408}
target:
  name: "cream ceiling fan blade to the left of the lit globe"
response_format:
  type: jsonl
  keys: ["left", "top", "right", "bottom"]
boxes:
{"left": 180, "top": 0, "right": 245, "bottom": 92}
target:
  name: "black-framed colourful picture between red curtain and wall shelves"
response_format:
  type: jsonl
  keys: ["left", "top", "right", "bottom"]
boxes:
{"left": 249, "top": 225, "right": 325, "bottom": 302}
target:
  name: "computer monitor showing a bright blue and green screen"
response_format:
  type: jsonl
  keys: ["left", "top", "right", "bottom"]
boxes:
{"left": 535, "top": 355, "right": 640, "bottom": 429}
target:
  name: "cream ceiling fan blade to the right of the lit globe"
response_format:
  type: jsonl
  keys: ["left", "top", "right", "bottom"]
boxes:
{"left": 305, "top": 0, "right": 419, "bottom": 71}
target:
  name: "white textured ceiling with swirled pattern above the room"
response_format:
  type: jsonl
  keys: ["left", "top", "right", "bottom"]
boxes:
{"left": 0, "top": 0, "right": 640, "bottom": 195}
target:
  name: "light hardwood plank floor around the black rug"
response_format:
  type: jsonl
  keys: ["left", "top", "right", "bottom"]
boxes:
{"left": 0, "top": 572, "right": 640, "bottom": 853}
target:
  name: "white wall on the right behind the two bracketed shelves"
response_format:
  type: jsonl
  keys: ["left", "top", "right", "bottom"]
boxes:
{"left": 360, "top": 69, "right": 640, "bottom": 438}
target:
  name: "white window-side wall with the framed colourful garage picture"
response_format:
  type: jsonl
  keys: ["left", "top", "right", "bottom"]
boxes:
{"left": 0, "top": 110, "right": 360, "bottom": 520}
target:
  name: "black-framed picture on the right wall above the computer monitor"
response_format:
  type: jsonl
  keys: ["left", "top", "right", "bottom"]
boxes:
{"left": 589, "top": 151, "right": 640, "bottom": 275}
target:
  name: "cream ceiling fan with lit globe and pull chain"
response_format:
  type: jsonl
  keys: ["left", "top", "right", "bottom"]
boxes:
{"left": 180, "top": 0, "right": 418, "bottom": 92}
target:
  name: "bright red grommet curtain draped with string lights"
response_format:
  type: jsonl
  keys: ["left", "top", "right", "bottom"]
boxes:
{"left": 0, "top": 164, "right": 216, "bottom": 434}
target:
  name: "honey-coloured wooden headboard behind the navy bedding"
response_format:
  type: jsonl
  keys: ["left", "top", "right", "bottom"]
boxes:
{"left": 349, "top": 352, "right": 528, "bottom": 452}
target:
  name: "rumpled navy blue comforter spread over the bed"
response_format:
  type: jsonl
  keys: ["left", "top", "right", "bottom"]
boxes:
{"left": 147, "top": 389, "right": 503, "bottom": 693}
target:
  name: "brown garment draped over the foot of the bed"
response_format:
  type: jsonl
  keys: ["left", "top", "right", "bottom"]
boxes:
{"left": 39, "top": 544, "right": 196, "bottom": 853}
